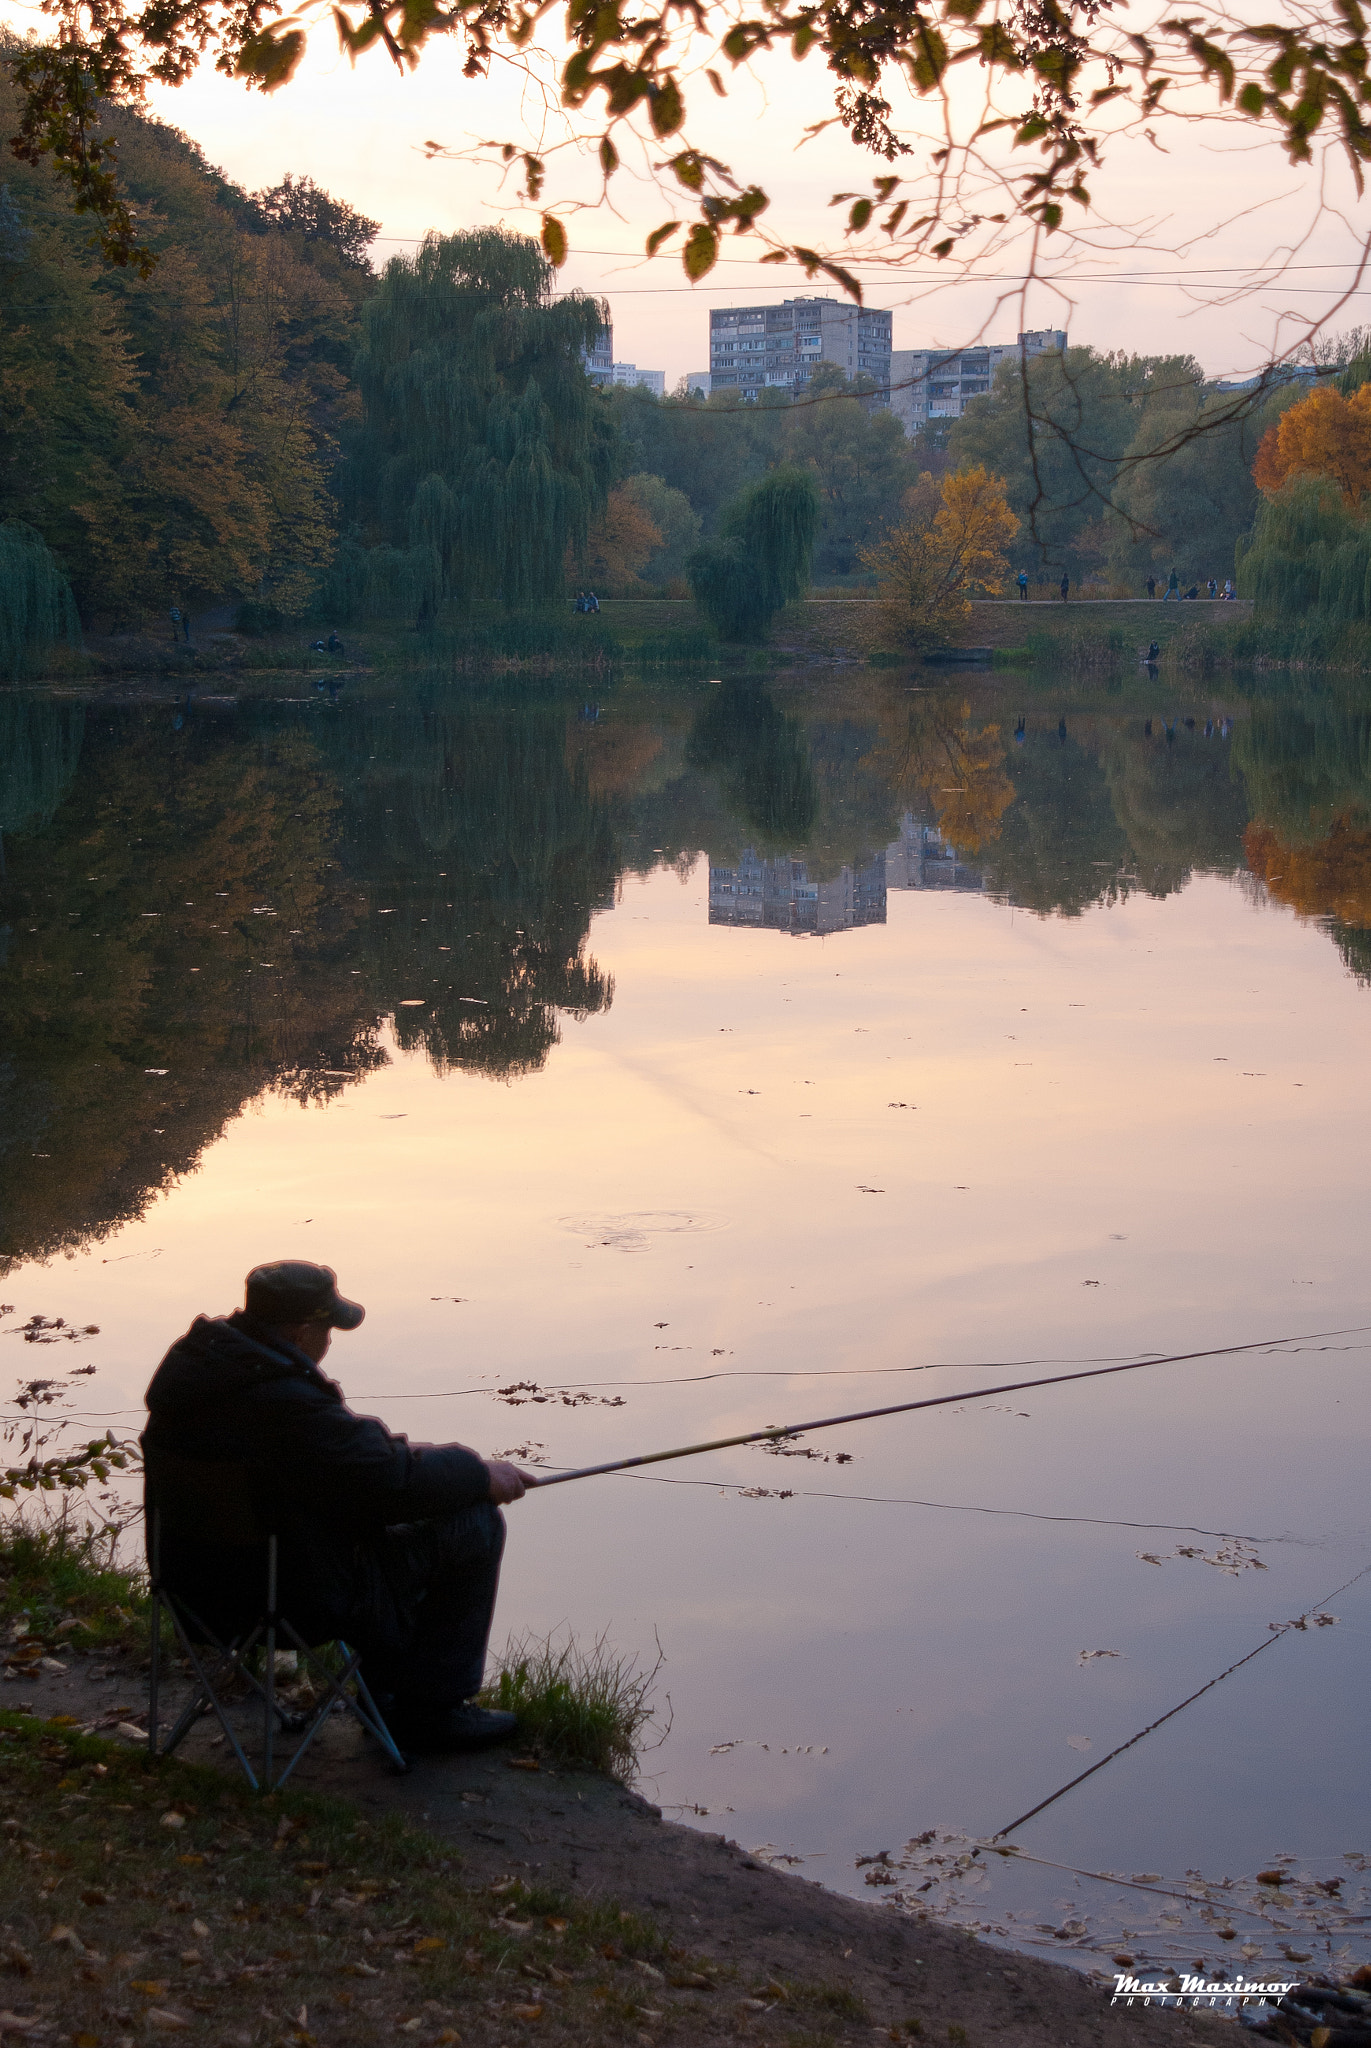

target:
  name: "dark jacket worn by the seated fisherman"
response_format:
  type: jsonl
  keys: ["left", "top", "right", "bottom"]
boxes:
{"left": 141, "top": 1311, "right": 490, "bottom": 1640}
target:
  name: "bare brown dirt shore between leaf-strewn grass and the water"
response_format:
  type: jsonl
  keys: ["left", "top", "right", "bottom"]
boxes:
{"left": 0, "top": 1651, "right": 1225, "bottom": 2048}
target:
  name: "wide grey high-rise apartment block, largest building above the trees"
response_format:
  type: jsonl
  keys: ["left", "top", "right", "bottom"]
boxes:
{"left": 709, "top": 297, "right": 891, "bottom": 399}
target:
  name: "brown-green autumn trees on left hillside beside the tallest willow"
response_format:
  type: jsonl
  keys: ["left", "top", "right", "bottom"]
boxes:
{"left": 0, "top": 66, "right": 375, "bottom": 627}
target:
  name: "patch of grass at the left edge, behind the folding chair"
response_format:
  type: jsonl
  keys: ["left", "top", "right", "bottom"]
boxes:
{"left": 0, "top": 1513, "right": 148, "bottom": 1655}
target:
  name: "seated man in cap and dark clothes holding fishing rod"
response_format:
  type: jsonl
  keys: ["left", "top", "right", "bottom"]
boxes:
{"left": 141, "top": 1260, "right": 531, "bottom": 1749}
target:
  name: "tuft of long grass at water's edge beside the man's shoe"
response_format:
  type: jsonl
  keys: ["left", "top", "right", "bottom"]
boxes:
{"left": 482, "top": 1634, "right": 662, "bottom": 1782}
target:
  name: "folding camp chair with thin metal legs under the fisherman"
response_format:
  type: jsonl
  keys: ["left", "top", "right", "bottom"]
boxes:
{"left": 146, "top": 1487, "right": 410, "bottom": 1792}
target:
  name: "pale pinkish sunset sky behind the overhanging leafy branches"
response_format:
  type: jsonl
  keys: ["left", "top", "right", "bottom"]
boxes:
{"left": 0, "top": 0, "right": 1371, "bottom": 389}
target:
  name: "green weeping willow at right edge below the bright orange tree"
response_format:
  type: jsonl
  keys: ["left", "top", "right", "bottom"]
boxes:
{"left": 1238, "top": 475, "right": 1371, "bottom": 637}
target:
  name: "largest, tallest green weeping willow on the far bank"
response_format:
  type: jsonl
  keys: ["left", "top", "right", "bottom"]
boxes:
{"left": 355, "top": 229, "right": 615, "bottom": 616}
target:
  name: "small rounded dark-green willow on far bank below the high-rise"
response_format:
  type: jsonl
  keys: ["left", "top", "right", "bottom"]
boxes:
{"left": 687, "top": 469, "right": 820, "bottom": 641}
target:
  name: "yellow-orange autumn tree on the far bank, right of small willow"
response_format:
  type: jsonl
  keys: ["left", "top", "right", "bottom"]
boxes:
{"left": 861, "top": 465, "right": 1019, "bottom": 647}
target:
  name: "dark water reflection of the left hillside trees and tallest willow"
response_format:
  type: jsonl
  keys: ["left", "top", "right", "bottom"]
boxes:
{"left": 0, "top": 700, "right": 615, "bottom": 1262}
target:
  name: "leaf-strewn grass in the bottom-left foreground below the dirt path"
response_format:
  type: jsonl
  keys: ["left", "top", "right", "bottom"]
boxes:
{"left": 0, "top": 1714, "right": 795, "bottom": 2048}
